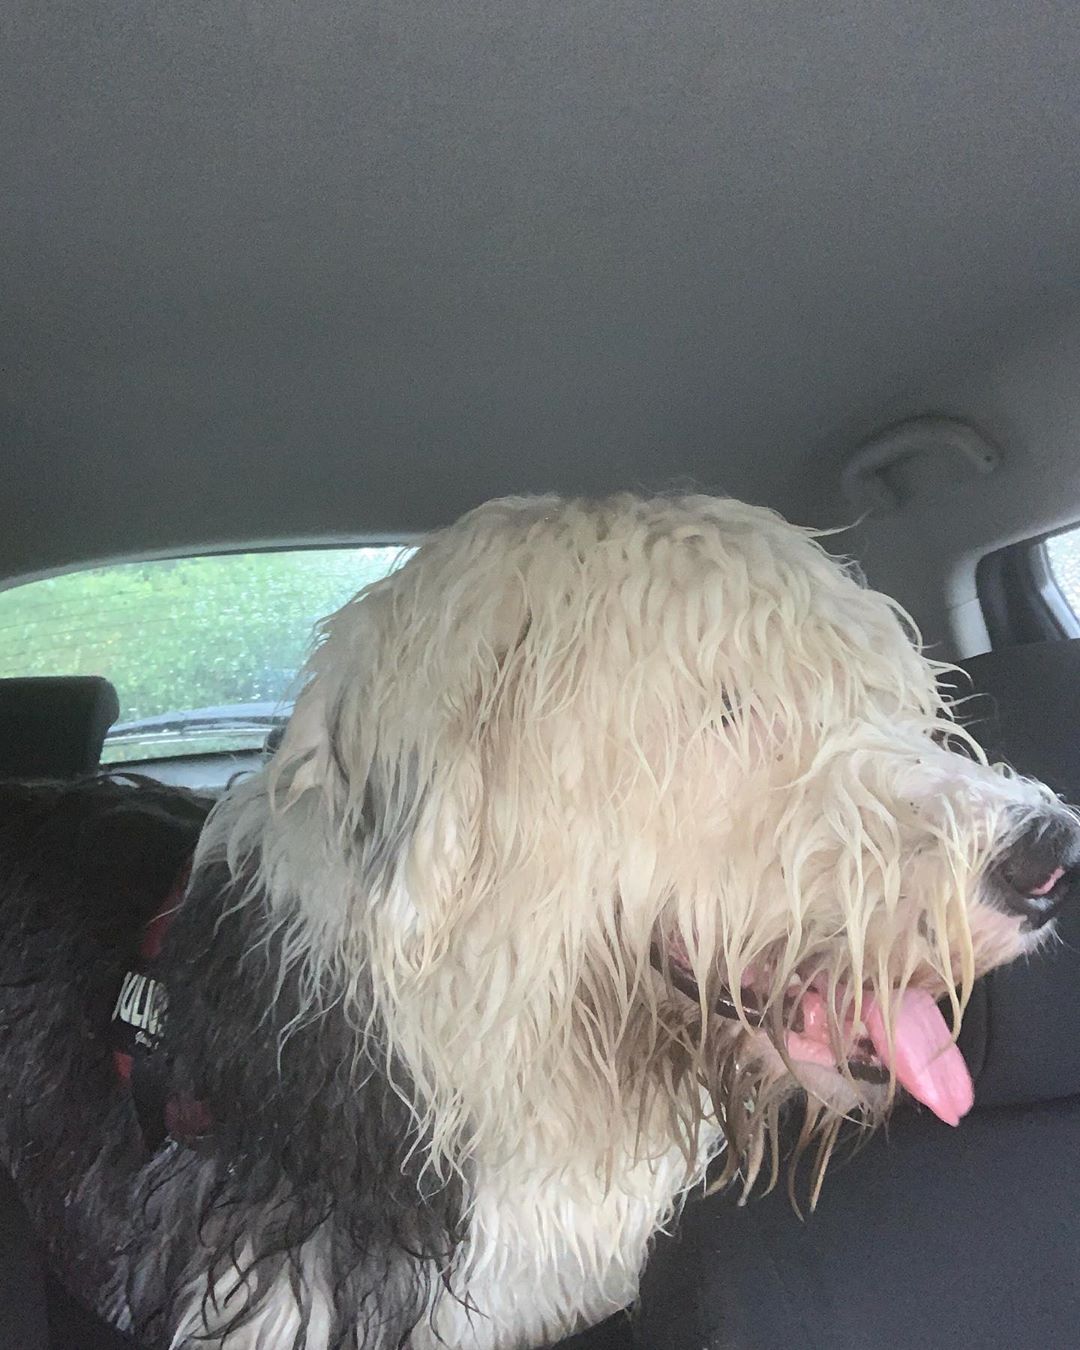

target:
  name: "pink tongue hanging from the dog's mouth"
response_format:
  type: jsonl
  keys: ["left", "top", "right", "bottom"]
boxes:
{"left": 863, "top": 990, "right": 975, "bottom": 1125}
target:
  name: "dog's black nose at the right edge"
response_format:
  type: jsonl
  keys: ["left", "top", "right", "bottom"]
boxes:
{"left": 991, "top": 813, "right": 1080, "bottom": 929}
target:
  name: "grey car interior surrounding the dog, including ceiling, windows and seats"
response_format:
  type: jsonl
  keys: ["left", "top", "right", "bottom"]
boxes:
{"left": 0, "top": 0, "right": 1080, "bottom": 1350}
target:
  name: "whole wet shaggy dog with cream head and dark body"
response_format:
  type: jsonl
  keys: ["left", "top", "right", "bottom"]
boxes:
{"left": 0, "top": 497, "right": 1080, "bottom": 1350}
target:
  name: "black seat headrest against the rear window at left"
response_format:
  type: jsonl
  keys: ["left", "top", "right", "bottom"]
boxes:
{"left": 0, "top": 675, "right": 120, "bottom": 779}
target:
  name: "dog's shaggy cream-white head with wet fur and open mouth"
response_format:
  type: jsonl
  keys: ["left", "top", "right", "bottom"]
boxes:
{"left": 261, "top": 497, "right": 1080, "bottom": 1193}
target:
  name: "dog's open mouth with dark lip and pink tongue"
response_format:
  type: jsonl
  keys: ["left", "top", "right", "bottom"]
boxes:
{"left": 653, "top": 953, "right": 975, "bottom": 1126}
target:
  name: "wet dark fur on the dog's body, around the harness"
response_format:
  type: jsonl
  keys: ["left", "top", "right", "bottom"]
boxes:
{"left": 0, "top": 779, "right": 459, "bottom": 1350}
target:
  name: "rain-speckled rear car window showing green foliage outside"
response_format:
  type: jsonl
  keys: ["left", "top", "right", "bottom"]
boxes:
{"left": 0, "top": 545, "right": 412, "bottom": 764}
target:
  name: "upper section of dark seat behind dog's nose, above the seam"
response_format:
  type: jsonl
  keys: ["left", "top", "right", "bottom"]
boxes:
{"left": 946, "top": 640, "right": 1080, "bottom": 1106}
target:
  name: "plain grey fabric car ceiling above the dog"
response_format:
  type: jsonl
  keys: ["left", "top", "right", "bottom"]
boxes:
{"left": 0, "top": 0, "right": 1080, "bottom": 594}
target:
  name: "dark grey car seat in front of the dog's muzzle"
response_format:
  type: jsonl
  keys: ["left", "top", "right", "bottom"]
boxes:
{"left": 636, "top": 641, "right": 1080, "bottom": 1350}
